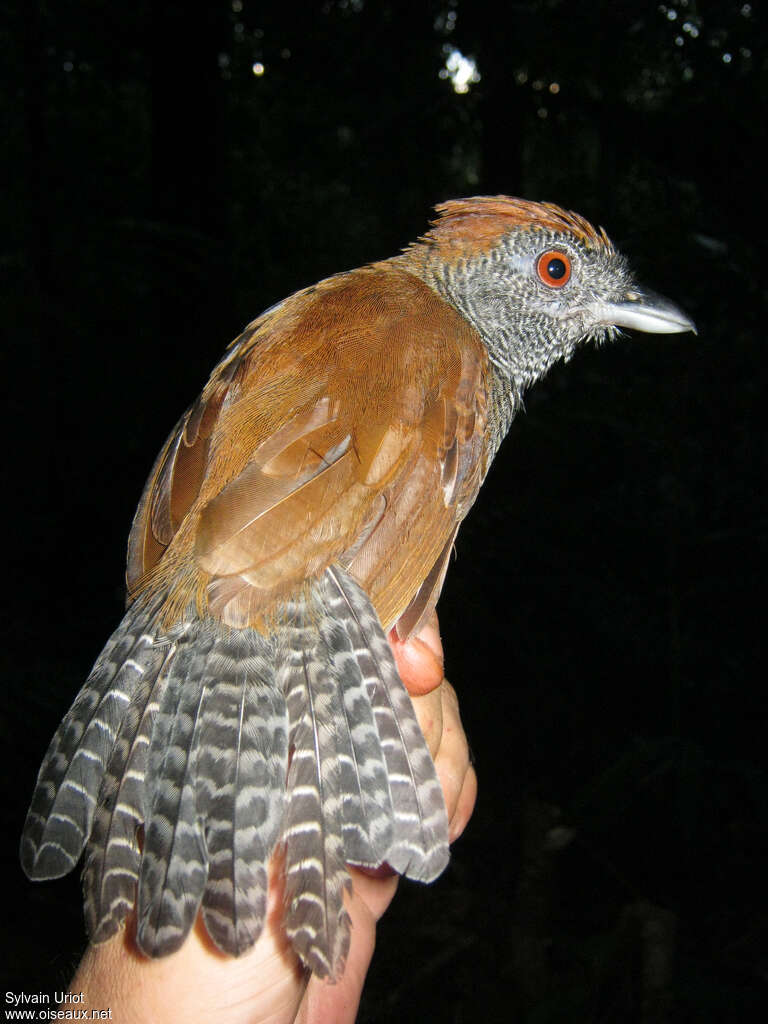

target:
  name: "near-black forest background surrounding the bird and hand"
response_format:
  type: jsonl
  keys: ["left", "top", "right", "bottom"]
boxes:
{"left": 0, "top": 0, "right": 768, "bottom": 1024}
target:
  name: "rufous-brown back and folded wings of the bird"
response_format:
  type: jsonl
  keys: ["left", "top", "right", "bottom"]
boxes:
{"left": 129, "top": 263, "right": 487, "bottom": 632}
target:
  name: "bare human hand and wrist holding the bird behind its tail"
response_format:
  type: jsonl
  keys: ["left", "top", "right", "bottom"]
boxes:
{"left": 75, "top": 615, "right": 477, "bottom": 1024}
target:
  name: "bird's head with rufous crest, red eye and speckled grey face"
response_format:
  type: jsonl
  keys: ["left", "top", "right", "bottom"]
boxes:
{"left": 407, "top": 196, "right": 695, "bottom": 400}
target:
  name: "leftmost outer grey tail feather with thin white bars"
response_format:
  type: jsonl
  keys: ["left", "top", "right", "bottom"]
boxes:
{"left": 20, "top": 604, "right": 163, "bottom": 880}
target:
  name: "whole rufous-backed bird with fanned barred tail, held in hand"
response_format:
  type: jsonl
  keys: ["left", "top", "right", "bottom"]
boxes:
{"left": 20, "top": 196, "right": 695, "bottom": 980}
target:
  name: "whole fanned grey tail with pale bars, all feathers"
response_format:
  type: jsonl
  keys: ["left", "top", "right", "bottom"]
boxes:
{"left": 22, "top": 567, "right": 449, "bottom": 977}
